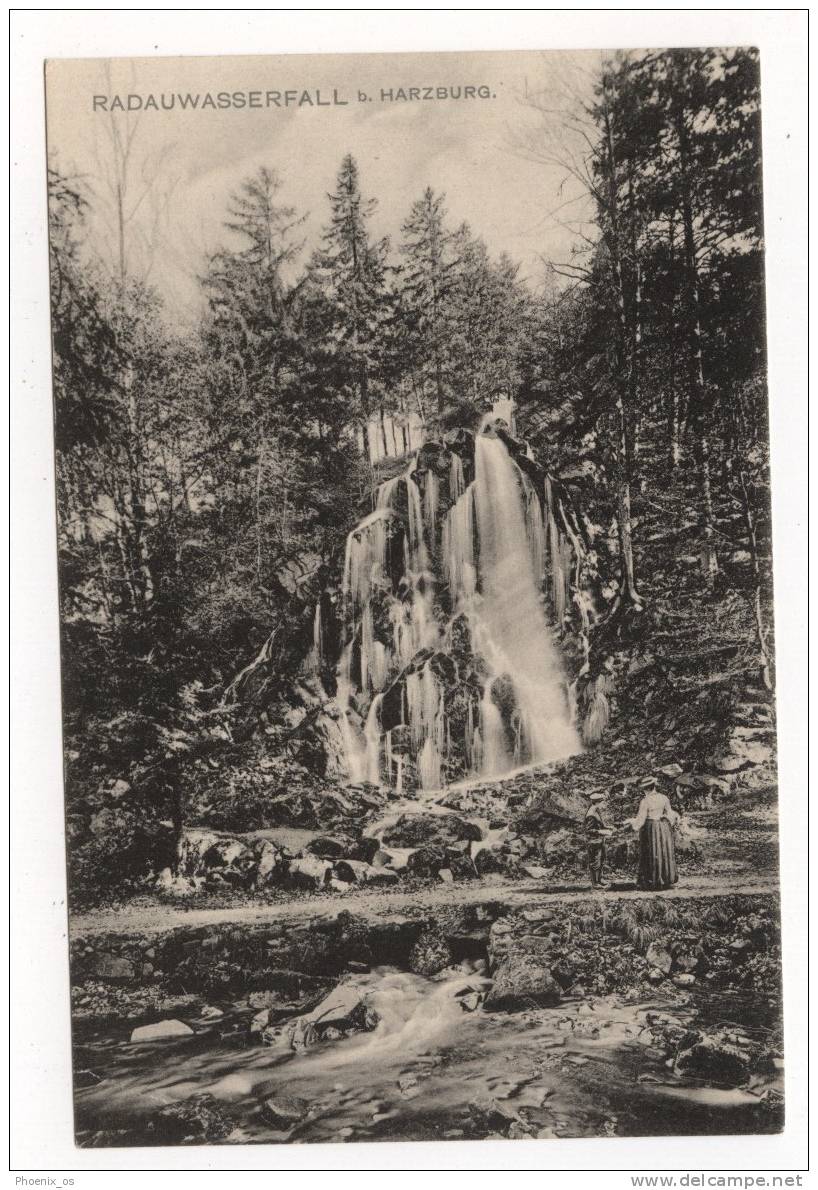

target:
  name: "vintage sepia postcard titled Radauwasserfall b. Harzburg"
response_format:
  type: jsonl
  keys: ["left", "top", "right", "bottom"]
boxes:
{"left": 46, "top": 46, "right": 785, "bottom": 1147}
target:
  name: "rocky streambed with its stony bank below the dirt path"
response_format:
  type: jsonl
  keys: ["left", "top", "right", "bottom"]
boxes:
{"left": 71, "top": 894, "right": 782, "bottom": 1146}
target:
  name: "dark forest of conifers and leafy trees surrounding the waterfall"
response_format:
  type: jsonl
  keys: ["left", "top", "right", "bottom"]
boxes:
{"left": 49, "top": 41, "right": 774, "bottom": 902}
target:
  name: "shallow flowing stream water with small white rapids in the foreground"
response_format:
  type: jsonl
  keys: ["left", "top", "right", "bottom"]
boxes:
{"left": 76, "top": 967, "right": 782, "bottom": 1146}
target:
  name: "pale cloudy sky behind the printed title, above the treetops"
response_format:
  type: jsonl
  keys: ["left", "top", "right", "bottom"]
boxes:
{"left": 46, "top": 48, "right": 599, "bottom": 320}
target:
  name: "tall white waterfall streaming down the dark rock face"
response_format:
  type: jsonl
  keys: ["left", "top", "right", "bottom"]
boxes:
{"left": 337, "top": 411, "right": 580, "bottom": 789}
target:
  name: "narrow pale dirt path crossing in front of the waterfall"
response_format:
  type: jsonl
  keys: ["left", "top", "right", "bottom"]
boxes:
{"left": 70, "top": 872, "right": 778, "bottom": 937}
